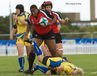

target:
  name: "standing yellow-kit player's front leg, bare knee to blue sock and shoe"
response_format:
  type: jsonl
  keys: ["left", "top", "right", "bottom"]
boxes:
{"left": 16, "top": 43, "right": 25, "bottom": 72}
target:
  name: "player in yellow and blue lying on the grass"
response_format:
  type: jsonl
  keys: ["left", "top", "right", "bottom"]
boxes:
{"left": 34, "top": 42, "right": 84, "bottom": 75}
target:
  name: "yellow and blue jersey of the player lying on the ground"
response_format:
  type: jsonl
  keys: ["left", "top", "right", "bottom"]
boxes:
{"left": 46, "top": 57, "right": 77, "bottom": 75}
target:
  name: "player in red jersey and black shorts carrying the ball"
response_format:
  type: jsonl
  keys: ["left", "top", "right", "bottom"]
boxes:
{"left": 25, "top": 5, "right": 57, "bottom": 74}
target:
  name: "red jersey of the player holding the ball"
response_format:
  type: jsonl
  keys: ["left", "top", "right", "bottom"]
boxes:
{"left": 29, "top": 10, "right": 52, "bottom": 35}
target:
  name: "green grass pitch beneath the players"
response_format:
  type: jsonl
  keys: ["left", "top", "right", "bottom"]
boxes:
{"left": 0, "top": 54, "right": 97, "bottom": 76}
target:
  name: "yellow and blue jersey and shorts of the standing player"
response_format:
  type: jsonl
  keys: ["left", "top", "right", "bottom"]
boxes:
{"left": 14, "top": 12, "right": 32, "bottom": 46}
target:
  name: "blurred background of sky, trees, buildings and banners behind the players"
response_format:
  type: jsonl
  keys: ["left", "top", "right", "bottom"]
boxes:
{"left": 0, "top": 0, "right": 97, "bottom": 56}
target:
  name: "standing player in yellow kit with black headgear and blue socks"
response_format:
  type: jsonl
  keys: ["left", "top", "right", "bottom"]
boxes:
{"left": 10, "top": 4, "right": 32, "bottom": 72}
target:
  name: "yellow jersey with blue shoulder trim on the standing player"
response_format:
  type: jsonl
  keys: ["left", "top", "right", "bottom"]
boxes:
{"left": 15, "top": 12, "right": 29, "bottom": 34}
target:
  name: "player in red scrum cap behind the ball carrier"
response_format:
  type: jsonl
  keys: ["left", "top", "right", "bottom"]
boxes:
{"left": 38, "top": 1, "right": 69, "bottom": 56}
